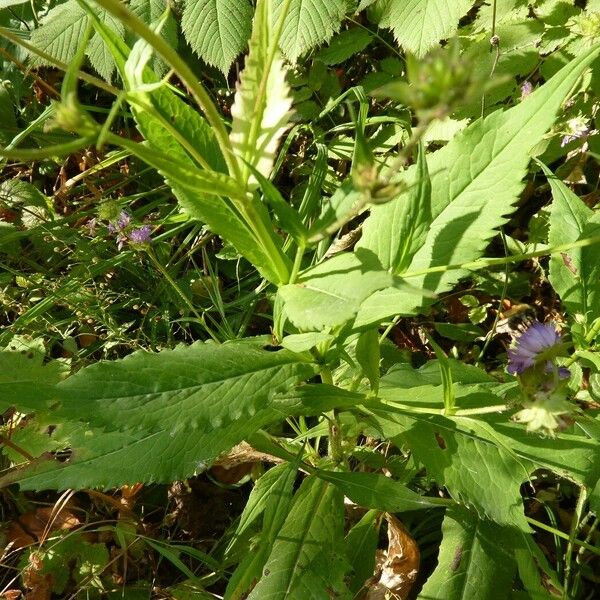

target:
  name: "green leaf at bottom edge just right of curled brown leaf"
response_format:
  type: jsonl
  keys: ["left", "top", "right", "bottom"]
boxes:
{"left": 418, "top": 507, "right": 515, "bottom": 600}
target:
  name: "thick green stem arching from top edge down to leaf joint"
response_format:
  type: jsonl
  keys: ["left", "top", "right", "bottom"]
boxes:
{"left": 91, "top": 0, "right": 241, "bottom": 181}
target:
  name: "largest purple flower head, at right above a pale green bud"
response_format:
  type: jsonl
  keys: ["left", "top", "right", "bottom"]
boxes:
{"left": 508, "top": 321, "right": 568, "bottom": 377}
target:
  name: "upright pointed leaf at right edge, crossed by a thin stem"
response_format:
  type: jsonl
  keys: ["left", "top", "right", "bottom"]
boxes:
{"left": 542, "top": 165, "right": 600, "bottom": 324}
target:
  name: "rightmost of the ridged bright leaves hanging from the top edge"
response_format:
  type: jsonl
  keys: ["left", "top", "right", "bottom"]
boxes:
{"left": 379, "top": 0, "right": 473, "bottom": 58}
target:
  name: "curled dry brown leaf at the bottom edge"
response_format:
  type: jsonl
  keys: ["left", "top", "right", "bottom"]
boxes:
{"left": 365, "top": 514, "right": 421, "bottom": 600}
